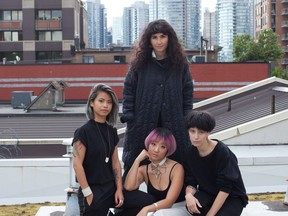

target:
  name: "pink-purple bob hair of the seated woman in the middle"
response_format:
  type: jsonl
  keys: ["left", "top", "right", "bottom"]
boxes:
{"left": 145, "top": 127, "right": 176, "bottom": 156}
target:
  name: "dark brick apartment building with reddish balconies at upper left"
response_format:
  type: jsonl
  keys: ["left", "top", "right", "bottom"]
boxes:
{"left": 0, "top": 0, "right": 87, "bottom": 64}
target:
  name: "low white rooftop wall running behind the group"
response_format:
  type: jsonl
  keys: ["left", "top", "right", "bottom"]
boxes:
{"left": 0, "top": 146, "right": 288, "bottom": 205}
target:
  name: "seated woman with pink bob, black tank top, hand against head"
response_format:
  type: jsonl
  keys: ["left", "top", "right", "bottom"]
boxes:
{"left": 113, "top": 127, "right": 190, "bottom": 216}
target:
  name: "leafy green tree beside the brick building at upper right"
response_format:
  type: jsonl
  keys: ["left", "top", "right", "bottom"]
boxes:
{"left": 233, "top": 29, "right": 284, "bottom": 62}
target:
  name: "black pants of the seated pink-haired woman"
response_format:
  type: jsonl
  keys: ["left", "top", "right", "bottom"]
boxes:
{"left": 116, "top": 190, "right": 156, "bottom": 216}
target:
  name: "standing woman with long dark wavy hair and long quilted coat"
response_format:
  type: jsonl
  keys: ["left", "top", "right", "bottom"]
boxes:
{"left": 121, "top": 19, "right": 193, "bottom": 178}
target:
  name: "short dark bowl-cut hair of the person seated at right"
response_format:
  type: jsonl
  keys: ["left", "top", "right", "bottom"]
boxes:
{"left": 186, "top": 110, "right": 216, "bottom": 132}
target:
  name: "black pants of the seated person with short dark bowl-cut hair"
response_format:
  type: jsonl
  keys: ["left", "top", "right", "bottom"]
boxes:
{"left": 193, "top": 191, "right": 243, "bottom": 216}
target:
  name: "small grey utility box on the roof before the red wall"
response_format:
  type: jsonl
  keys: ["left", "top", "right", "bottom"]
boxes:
{"left": 11, "top": 91, "right": 34, "bottom": 109}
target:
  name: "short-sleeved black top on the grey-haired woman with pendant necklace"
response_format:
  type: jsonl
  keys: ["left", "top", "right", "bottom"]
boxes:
{"left": 72, "top": 120, "right": 119, "bottom": 185}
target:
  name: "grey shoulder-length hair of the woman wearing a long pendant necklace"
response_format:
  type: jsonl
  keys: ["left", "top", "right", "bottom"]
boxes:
{"left": 86, "top": 83, "right": 119, "bottom": 125}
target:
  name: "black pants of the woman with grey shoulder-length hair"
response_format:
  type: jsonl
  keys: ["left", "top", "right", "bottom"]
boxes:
{"left": 78, "top": 182, "right": 116, "bottom": 216}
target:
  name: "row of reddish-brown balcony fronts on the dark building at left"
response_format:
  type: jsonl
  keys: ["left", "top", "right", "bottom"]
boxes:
{"left": 0, "top": 20, "right": 62, "bottom": 31}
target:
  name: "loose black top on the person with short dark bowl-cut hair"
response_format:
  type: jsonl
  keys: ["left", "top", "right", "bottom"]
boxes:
{"left": 184, "top": 140, "right": 248, "bottom": 207}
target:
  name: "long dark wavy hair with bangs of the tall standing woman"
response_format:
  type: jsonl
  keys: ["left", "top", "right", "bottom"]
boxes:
{"left": 131, "top": 19, "right": 187, "bottom": 72}
